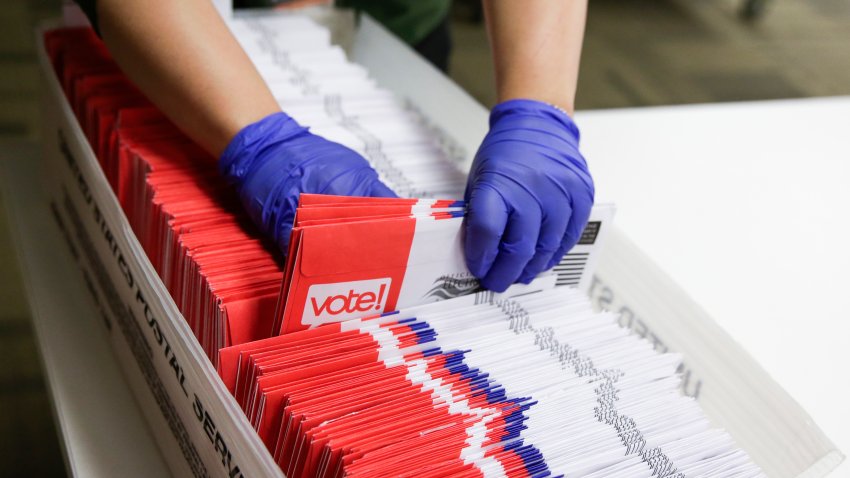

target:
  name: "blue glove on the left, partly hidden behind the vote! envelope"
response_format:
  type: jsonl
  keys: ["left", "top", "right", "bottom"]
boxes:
{"left": 219, "top": 113, "right": 396, "bottom": 254}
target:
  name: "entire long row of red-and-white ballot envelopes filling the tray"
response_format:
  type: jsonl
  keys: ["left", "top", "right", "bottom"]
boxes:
{"left": 45, "top": 16, "right": 762, "bottom": 478}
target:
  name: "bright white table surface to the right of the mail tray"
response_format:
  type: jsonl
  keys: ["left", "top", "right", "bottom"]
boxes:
{"left": 576, "top": 97, "right": 850, "bottom": 476}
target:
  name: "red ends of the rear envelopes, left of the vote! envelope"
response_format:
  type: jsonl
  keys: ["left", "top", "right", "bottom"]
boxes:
{"left": 45, "top": 28, "right": 283, "bottom": 361}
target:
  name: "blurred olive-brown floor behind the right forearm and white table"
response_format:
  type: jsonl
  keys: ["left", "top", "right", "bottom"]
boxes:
{"left": 450, "top": 0, "right": 850, "bottom": 109}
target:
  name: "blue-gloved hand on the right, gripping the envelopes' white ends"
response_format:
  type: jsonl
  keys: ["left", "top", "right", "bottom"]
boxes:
{"left": 464, "top": 100, "right": 594, "bottom": 292}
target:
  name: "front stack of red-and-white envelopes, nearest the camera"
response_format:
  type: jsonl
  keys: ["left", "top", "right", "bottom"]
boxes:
{"left": 219, "top": 286, "right": 763, "bottom": 478}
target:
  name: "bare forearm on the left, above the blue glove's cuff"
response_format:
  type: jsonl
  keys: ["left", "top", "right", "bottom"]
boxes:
{"left": 97, "top": 0, "right": 280, "bottom": 156}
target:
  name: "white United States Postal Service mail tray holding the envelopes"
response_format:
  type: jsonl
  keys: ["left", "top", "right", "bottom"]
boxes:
{"left": 38, "top": 9, "right": 842, "bottom": 478}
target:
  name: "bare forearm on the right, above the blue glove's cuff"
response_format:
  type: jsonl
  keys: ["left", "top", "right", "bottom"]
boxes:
{"left": 484, "top": 0, "right": 587, "bottom": 114}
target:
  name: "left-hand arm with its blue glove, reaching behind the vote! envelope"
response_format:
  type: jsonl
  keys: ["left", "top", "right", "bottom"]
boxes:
{"left": 89, "top": 0, "right": 395, "bottom": 254}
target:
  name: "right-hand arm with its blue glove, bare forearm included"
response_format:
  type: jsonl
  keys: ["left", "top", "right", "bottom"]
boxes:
{"left": 464, "top": 0, "right": 594, "bottom": 292}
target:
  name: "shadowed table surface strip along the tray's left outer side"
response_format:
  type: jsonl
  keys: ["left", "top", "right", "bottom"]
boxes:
{"left": 0, "top": 143, "right": 170, "bottom": 478}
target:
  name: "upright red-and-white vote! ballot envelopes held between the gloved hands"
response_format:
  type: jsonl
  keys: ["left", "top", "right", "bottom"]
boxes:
{"left": 276, "top": 193, "right": 611, "bottom": 333}
